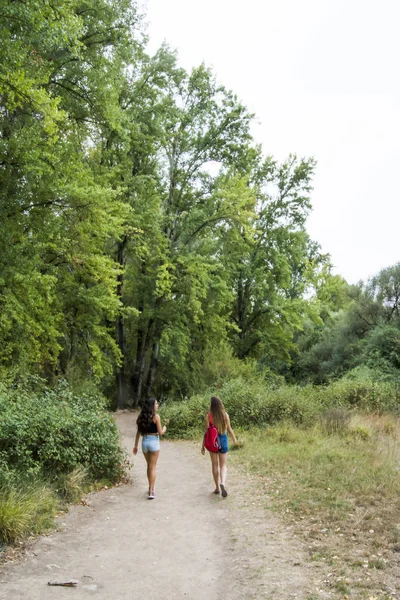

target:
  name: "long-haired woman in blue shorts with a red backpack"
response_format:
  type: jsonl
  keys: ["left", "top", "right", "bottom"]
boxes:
{"left": 201, "top": 396, "right": 237, "bottom": 498}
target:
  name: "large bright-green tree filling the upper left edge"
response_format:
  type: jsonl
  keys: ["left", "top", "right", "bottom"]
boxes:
{"left": 0, "top": 0, "right": 141, "bottom": 377}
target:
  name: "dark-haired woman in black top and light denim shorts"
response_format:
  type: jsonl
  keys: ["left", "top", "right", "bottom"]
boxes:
{"left": 133, "top": 398, "right": 167, "bottom": 500}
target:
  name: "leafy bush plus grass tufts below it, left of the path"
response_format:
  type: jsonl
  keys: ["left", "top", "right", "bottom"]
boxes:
{"left": 0, "top": 378, "right": 124, "bottom": 545}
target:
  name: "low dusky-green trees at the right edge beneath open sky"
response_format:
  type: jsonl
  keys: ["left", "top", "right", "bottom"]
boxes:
{"left": 291, "top": 265, "right": 400, "bottom": 383}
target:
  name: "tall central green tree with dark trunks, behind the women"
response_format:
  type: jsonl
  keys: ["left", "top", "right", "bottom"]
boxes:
{"left": 118, "top": 47, "right": 253, "bottom": 403}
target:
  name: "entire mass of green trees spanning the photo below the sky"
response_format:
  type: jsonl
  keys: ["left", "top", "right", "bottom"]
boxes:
{"left": 0, "top": 0, "right": 400, "bottom": 406}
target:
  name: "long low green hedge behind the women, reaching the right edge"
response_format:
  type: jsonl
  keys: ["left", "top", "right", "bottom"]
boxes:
{"left": 161, "top": 376, "right": 397, "bottom": 438}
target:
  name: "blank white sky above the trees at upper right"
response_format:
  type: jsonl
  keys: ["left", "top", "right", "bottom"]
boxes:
{"left": 143, "top": 0, "right": 400, "bottom": 283}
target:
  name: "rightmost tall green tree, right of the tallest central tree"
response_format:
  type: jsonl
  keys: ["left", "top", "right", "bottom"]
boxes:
{"left": 224, "top": 154, "right": 321, "bottom": 366}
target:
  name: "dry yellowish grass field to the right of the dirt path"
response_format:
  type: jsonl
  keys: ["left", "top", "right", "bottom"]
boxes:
{"left": 232, "top": 415, "right": 400, "bottom": 598}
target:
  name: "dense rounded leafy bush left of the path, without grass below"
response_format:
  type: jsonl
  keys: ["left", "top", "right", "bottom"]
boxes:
{"left": 0, "top": 383, "right": 123, "bottom": 480}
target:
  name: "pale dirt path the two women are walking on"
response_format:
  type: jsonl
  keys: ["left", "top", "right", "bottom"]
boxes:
{"left": 0, "top": 411, "right": 333, "bottom": 600}
